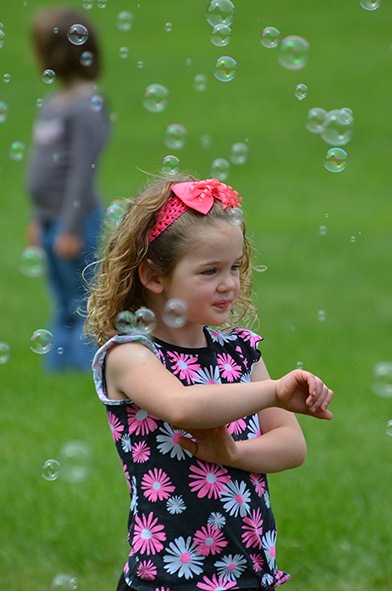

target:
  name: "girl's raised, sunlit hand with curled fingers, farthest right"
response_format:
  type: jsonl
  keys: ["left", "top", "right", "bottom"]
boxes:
{"left": 276, "top": 369, "right": 333, "bottom": 420}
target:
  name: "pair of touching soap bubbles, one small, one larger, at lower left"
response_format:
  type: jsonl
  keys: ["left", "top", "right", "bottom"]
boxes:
{"left": 41, "top": 439, "right": 92, "bottom": 483}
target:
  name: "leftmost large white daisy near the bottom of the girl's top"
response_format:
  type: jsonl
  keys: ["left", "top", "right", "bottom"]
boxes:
{"left": 163, "top": 536, "right": 204, "bottom": 579}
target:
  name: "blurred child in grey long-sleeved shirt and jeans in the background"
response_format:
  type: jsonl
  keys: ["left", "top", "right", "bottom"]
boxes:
{"left": 26, "top": 7, "right": 109, "bottom": 371}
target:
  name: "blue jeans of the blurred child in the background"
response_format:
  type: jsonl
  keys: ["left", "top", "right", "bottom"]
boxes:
{"left": 42, "top": 208, "right": 102, "bottom": 371}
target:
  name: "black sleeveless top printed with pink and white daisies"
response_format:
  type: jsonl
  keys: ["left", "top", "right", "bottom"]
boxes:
{"left": 93, "top": 327, "right": 289, "bottom": 591}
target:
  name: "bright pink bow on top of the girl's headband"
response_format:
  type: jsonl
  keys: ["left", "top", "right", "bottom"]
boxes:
{"left": 171, "top": 179, "right": 242, "bottom": 215}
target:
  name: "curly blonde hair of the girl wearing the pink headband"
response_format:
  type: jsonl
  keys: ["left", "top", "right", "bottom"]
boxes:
{"left": 85, "top": 175, "right": 257, "bottom": 346}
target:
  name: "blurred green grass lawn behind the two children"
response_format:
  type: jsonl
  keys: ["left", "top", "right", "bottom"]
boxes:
{"left": 0, "top": 0, "right": 392, "bottom": 591}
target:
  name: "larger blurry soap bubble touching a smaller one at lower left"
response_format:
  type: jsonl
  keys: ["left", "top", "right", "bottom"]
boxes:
{"left": 59, "top": 439, "right": 92, "bottom": 482}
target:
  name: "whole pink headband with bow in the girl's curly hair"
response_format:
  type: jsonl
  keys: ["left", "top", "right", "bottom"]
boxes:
{"left": 149, "top": 179, "right": 242, "bottom": 242}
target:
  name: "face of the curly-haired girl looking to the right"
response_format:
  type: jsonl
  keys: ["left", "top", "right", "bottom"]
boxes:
{"left": 162, "top": 222, "right": 243, "bottom": 327}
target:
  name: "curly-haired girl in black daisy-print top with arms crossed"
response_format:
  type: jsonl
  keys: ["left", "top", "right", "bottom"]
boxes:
{"left": 86, "top": 176, "right": 333, "bottom": 591}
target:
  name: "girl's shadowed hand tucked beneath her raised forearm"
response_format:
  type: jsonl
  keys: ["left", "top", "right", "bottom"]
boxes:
{"left": 173, "top": 426, "right": 238, "bottom": 466}
